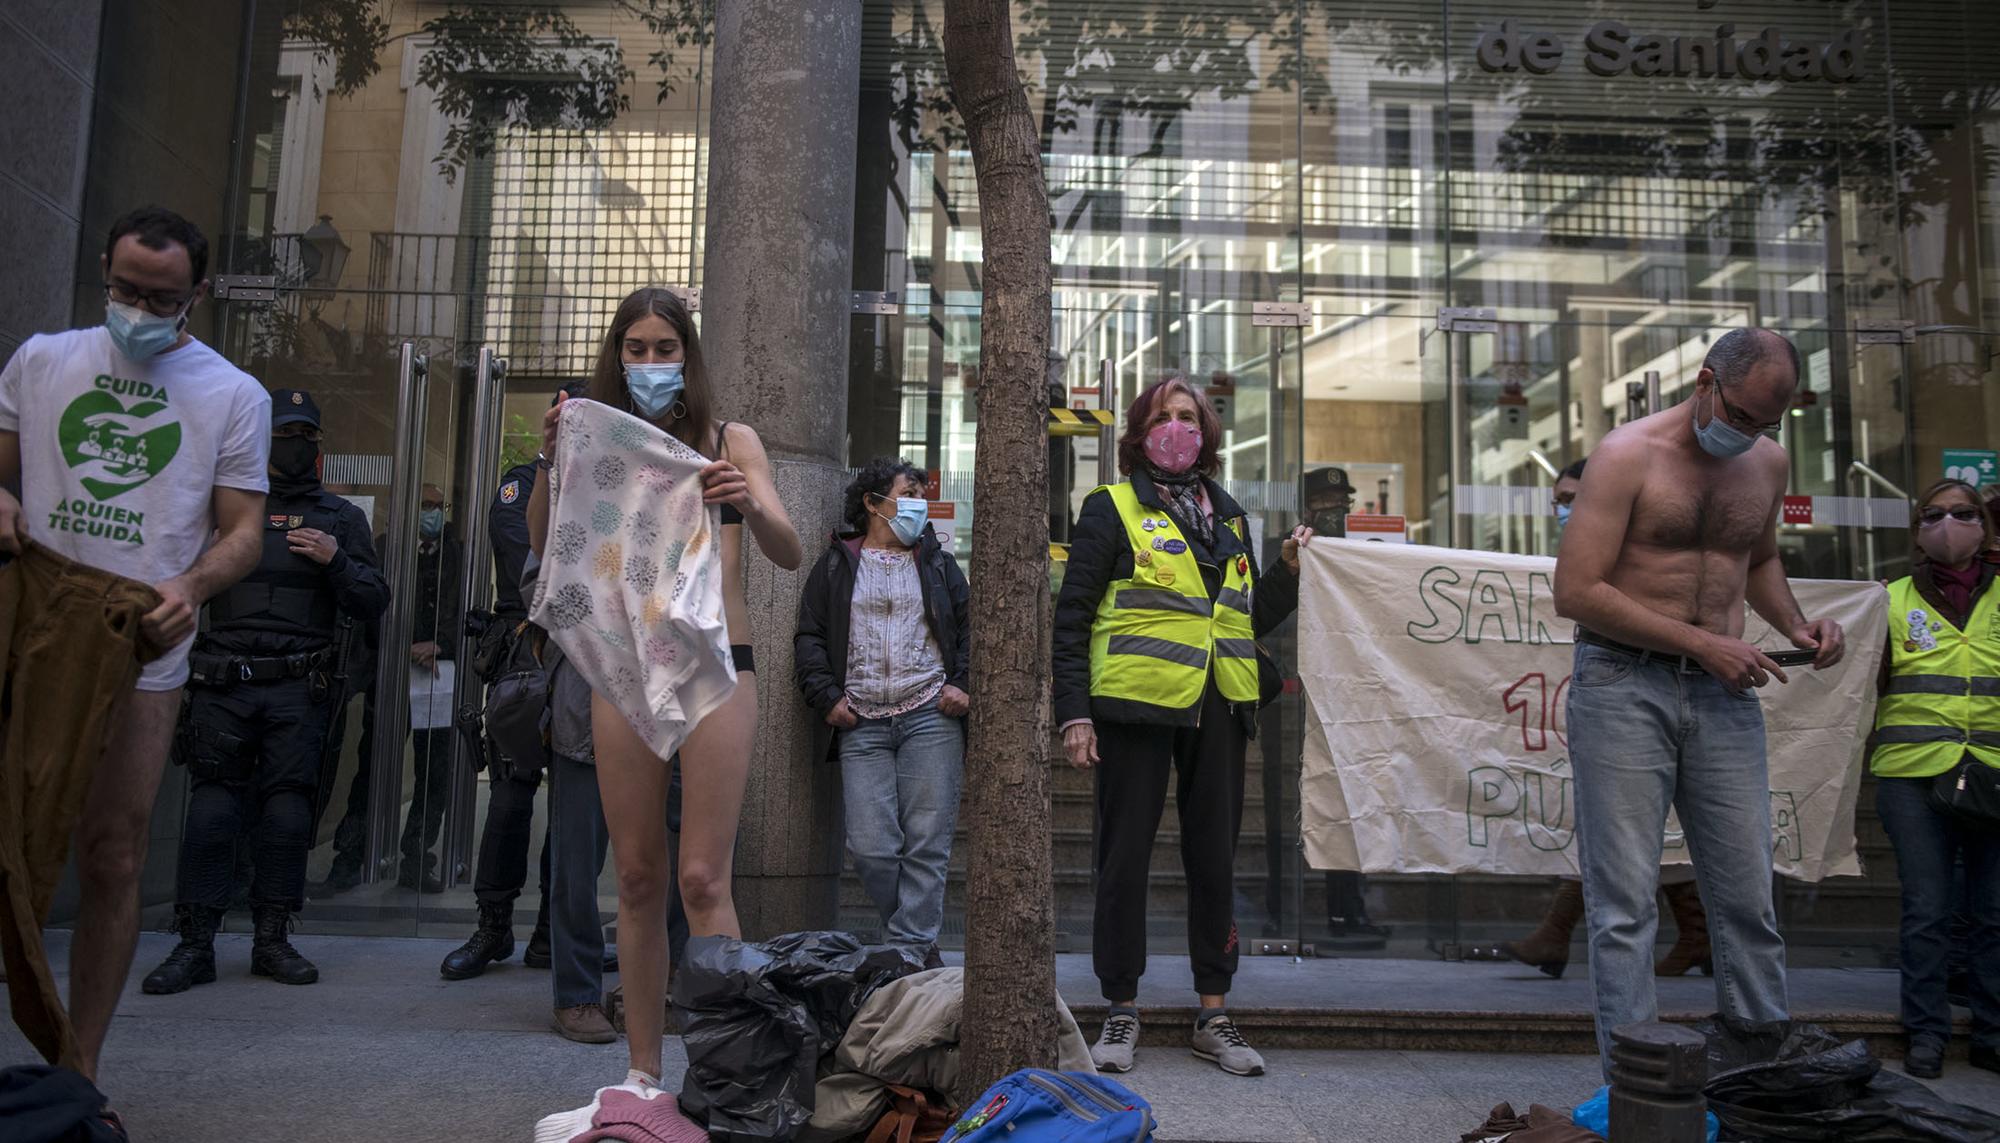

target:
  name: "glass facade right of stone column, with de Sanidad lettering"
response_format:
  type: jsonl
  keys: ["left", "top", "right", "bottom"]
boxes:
{"left": 850, "top": 0, "right": 2000, "bottom": 959}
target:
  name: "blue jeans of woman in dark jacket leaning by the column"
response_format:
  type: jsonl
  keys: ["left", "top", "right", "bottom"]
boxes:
{"left": 836, "top": 701, "right": 966, "bottom": 945}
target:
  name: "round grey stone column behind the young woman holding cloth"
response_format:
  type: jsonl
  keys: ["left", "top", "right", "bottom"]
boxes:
{"left": 702, "top": 0, "right": 862, "bottom": 939}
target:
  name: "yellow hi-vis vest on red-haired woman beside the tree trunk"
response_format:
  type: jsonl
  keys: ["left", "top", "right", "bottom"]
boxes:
{"left": 1090, "top": 484, "right": 1258, "bottom": 709}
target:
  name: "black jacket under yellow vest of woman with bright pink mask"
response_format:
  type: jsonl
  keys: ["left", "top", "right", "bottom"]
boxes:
{"left": 1052, "top": 472, "right": 1298, "bottom": 727}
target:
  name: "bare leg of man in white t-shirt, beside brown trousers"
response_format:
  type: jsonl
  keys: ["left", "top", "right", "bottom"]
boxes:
{"left": 70, "top": 687, "right": 180, "bottom": 1081}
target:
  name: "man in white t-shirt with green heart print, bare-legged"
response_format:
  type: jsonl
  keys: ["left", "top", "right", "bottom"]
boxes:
{"left": 0, "top": 208, "right": 270, "bottom": 1079}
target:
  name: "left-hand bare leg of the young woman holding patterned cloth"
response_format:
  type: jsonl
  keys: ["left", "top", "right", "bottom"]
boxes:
{"left": 590, "top": 695, "right": 680, "bottom": 1079}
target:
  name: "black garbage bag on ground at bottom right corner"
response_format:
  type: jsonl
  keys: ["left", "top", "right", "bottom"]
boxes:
{"left": 1694, "top": 1015, "right": 2000, "bottom": 1143}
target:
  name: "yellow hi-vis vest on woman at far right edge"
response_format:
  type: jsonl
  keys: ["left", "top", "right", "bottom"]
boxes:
{"left": 1868, "top": 575, "right": 2000, "bottom": 777}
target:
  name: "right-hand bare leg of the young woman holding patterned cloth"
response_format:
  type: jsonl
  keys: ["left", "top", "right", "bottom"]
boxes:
{"left": 680, "top": 673, "right": 756, "bottom": 937}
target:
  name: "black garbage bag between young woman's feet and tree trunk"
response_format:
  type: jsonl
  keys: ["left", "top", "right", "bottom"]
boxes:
{"left": 674, "top": 933, "right": 924, "bottom": 1143}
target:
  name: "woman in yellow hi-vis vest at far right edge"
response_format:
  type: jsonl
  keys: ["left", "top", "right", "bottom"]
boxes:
{"left": 1868, "top": 480, "right": 2000, "bottom": 1079}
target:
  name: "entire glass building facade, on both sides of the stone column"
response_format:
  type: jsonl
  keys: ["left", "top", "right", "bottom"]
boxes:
{"left": 54, "top": 0, "right": 2000, "bottom": 959}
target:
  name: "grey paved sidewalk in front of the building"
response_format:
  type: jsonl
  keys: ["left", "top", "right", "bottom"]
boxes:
{"left": 0, "top": 933, "right": 2000, "bottom": 1143}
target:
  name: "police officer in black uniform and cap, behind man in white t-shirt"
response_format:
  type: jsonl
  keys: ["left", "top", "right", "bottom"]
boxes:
{"left": 144, "top": 390, "right": 388, "bottom": 993}
